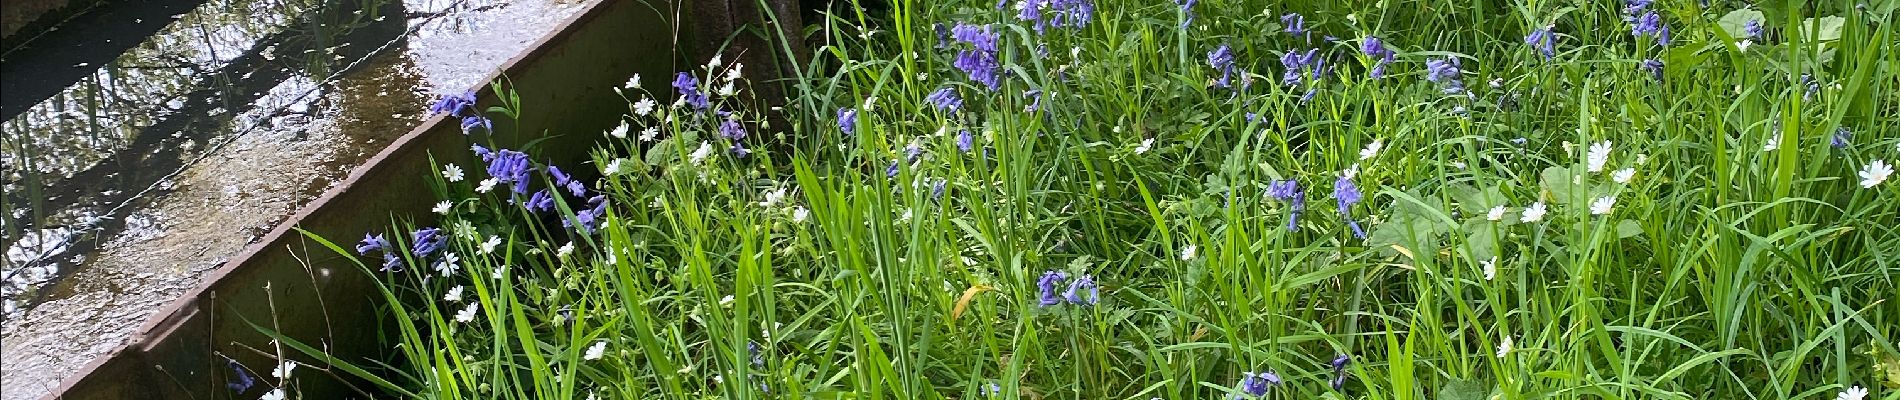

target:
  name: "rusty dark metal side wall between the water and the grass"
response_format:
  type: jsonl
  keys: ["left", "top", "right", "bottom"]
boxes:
{"left": 48, "top": 0, "right": 680, "bottom": 398}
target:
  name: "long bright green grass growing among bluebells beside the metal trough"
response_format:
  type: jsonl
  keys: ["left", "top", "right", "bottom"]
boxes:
{"left": 260, "top": 0, "right": 1900, "bottom": 400}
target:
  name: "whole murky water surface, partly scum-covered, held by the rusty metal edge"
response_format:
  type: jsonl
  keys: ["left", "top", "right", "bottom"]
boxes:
{"left": 0, "top": 0, "right": 593, "bottom": 400}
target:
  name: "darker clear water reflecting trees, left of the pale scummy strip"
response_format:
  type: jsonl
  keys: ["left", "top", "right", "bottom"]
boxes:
{"left": 0, "top": 0, "right": 414, "bottom": 314}
